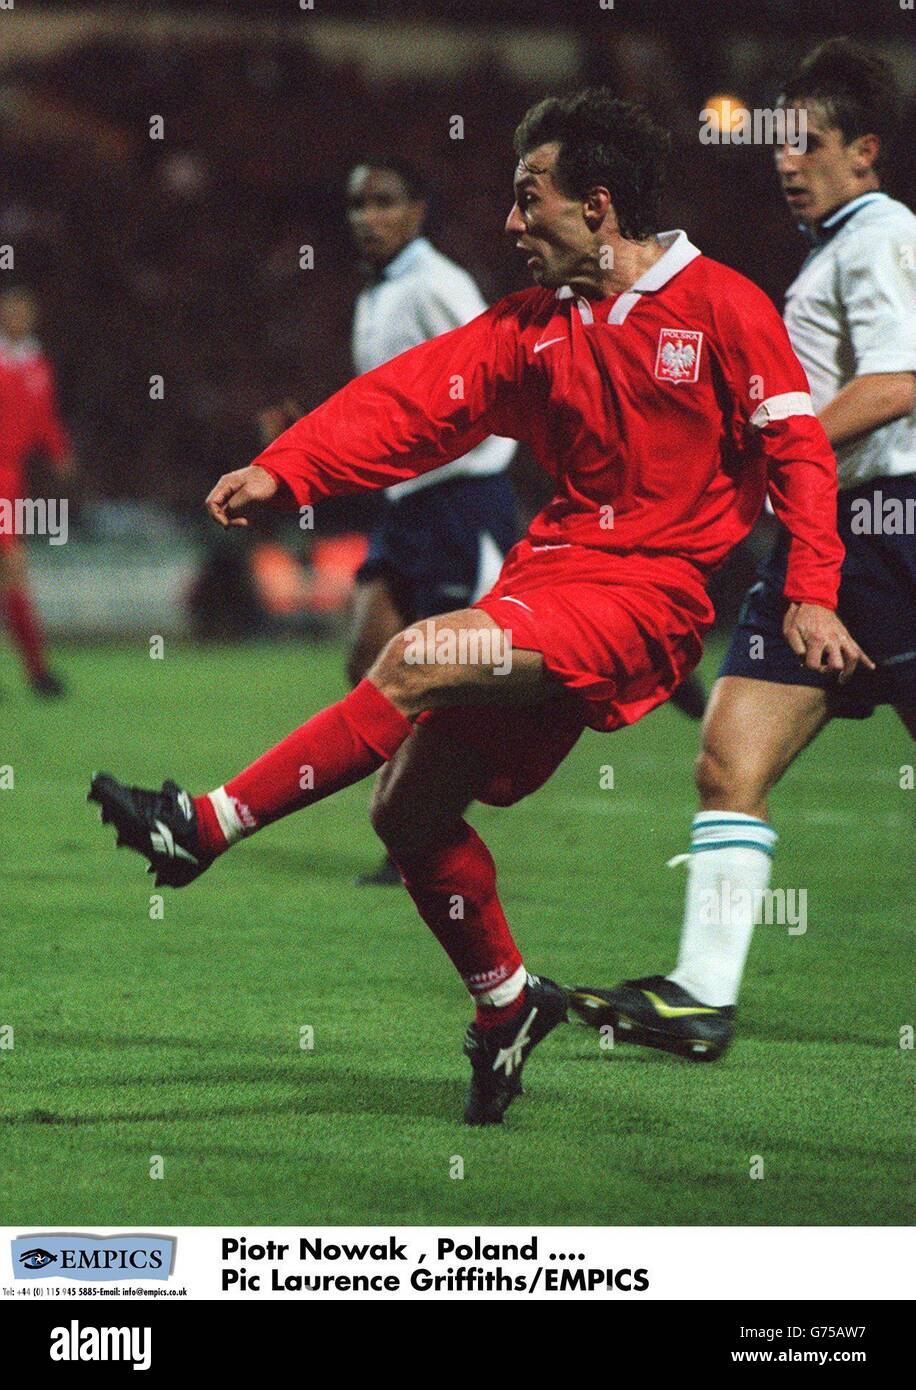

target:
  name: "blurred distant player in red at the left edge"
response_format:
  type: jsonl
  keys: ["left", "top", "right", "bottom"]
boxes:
{"left": 0, "top": 288, "right": 74, "bottom": 698}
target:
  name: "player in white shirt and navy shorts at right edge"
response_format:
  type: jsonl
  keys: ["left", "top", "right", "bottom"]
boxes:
{"left": 574, "top": 39, "right": 916, "bottom": 1061}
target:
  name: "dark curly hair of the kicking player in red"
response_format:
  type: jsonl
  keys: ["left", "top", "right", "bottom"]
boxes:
{"left": 514, "top": 88, "right": 671, "bottom": 242}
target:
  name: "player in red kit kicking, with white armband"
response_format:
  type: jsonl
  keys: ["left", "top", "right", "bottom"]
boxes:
{"left": 90, "top": 89, "right": 862, "bottom": 1125}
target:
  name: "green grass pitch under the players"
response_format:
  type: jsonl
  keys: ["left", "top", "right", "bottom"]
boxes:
{"left": 0, "top": 642, "right": 916, "bottom": 1229}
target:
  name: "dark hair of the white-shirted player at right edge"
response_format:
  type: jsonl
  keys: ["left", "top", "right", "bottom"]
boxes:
{"left": 780, "top": 39, "right": 898, "bottom": 167}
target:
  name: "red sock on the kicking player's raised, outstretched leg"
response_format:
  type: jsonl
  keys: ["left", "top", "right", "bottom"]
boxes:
{"left": 195, "top": 681, "right": 413, "bottom": 853}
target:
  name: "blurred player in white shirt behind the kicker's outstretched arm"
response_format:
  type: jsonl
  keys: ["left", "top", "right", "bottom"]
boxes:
{"left": 261, "top": 157, "right": 518, "bottom": 884}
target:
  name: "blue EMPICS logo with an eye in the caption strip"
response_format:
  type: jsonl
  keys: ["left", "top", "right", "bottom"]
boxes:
{"left": 13, "top": 1232, "right": 175, "bottom": 1283}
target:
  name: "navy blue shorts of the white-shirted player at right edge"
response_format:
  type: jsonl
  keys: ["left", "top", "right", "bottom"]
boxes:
{"left": 719, "top": 474, "right": 916, "bottom": 719}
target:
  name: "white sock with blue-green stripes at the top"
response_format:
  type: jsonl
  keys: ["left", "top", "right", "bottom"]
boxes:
{"left": 667, "top": 810, "right": 778, "bottom": 1008}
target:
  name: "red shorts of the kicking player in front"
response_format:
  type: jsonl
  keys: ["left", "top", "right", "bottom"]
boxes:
{"left": 421, "top": 541, "right": 714, "bottom": 806}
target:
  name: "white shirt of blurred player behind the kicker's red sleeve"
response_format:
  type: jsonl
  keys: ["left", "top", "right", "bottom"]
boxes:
{"left": 353, "top": 236, "right": 516, "bottom": 500}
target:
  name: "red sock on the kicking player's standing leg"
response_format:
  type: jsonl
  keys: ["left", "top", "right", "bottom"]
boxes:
{"left": 393, "top": 820, "right": 524, "bottom": 1027}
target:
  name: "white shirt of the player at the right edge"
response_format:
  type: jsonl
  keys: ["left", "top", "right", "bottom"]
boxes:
{"left": 785, "top": 192, "right": 916, "bottom": 488}
